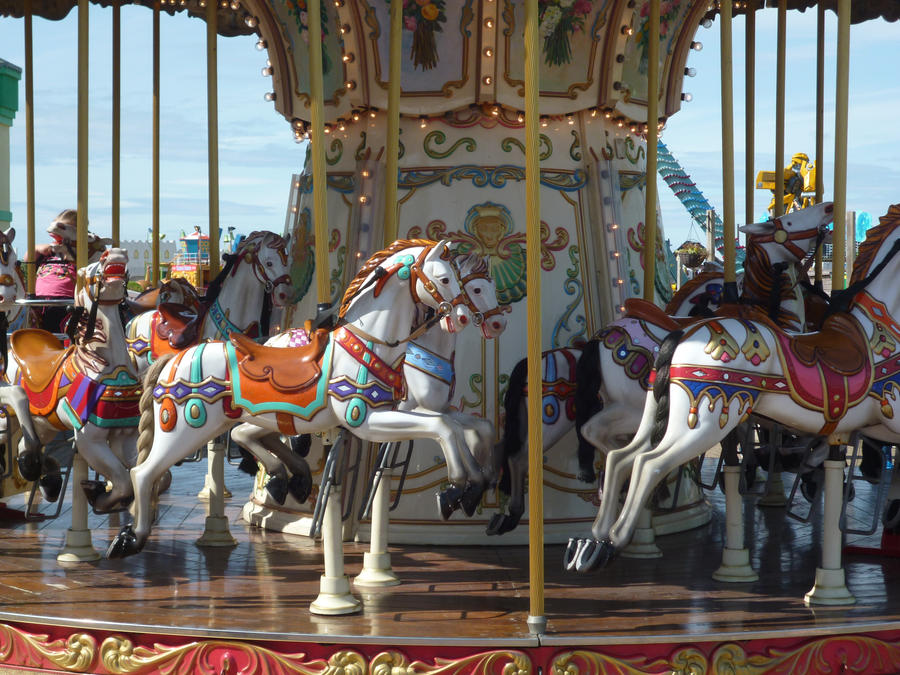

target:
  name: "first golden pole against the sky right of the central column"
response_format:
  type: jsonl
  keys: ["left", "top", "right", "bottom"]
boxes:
{"left": 719, "top": 0, "right": 738, "bottom": 290}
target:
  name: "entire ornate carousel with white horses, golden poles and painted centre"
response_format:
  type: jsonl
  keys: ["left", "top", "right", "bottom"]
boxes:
{"left": 0, "top": 0, "right": 900, "bottom": 674}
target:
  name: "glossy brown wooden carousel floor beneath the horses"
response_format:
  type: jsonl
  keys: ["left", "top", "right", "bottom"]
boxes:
{"left": 0, "top": 454, "right": 900, "bottom": 648}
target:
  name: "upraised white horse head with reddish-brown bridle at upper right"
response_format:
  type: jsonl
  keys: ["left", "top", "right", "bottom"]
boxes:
{"left": 740, "top": 202, "right": 834, "bottom": 265}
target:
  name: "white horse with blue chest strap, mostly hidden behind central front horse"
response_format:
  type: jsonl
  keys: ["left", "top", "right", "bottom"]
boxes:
{"left": 231, "top": 254, "right": 508, "bottom": 518}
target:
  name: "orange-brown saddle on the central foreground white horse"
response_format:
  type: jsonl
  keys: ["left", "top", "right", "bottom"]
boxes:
{"left": 228, "top": 329, "right": 329, "bottom": 393}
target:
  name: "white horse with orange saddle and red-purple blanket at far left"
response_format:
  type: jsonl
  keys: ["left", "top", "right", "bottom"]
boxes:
{"left": 8, "top": 248, "right": 140, "bottom": 513}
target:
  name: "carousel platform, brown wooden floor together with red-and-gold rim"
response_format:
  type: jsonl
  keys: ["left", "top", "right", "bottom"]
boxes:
{"left": 0, "top": 465, "right": 900, "bottom": 675}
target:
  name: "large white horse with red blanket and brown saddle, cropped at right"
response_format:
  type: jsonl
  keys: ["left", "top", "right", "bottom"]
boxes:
{"left": 577, "top": 205, "right": 900, "bottom": 571}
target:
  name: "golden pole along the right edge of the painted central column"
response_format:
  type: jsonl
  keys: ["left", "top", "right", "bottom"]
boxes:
{"left": 640, "top": 0, "right": 659, "bottom": 302}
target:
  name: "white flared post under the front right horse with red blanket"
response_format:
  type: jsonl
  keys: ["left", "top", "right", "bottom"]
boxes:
{"left": 803, "top": 439, "right": 856, "bottom": 605}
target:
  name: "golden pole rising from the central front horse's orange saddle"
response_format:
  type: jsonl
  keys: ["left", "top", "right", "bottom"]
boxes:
{"left": 307, "top": 0, "right": 328, "bottom": 304}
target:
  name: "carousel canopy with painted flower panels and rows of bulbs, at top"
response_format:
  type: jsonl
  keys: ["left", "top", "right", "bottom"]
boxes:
{"left": 0, "top": 0, "right": 900, "bottom": 128}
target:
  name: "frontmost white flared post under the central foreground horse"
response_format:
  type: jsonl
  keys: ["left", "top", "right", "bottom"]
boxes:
{"left": 309, "top": 435, "right": 362, "bottom": 615}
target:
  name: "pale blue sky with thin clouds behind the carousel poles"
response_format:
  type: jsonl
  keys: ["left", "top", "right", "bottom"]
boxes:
{"left": 0, "top": 6, "right": 900, "bottom": 254}
